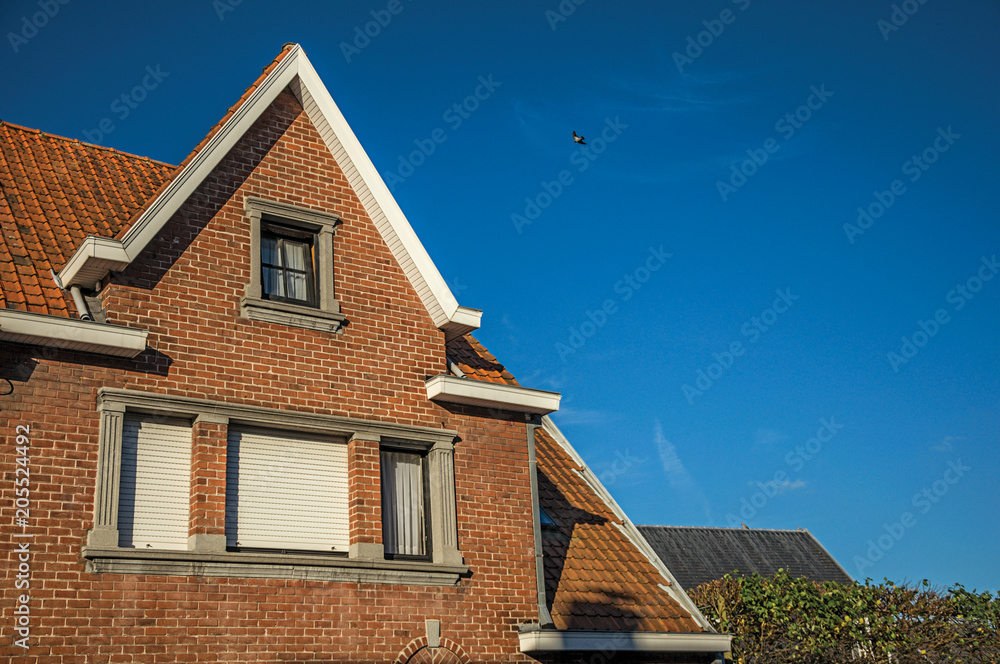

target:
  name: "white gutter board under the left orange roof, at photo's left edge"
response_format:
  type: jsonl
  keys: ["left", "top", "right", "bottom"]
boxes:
{"left": 0, "top": 309, "right": 148, "bottom": 357}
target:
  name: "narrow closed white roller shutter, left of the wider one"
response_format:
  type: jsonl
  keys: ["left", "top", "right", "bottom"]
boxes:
{"left": 118, "top": 416, "right": 191, "bottom": 549}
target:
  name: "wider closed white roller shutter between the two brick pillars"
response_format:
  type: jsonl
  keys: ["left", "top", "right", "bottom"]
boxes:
{"left": 226, "top": 427, "right": 350, "bottom": 552}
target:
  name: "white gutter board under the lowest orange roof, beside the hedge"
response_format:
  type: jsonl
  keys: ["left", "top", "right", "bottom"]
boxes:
{"left": 518, "top": 629, "right": 732, "bottom": 653}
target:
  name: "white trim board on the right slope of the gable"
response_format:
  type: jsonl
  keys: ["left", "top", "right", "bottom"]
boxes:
{"left": 289, "top": 47, "right": 482, "bottom": 336}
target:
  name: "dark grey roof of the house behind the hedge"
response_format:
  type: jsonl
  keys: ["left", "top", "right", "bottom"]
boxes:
{"left": 639, "top": 526, "right": 852, "bottom": 589}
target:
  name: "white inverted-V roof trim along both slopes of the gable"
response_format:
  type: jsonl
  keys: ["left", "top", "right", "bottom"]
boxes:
{"left": 59, "top": 45, "right": 482, "bottom": 339}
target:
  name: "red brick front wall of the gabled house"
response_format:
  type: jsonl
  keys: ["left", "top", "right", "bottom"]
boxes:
{"left": 0, "top": 93, "right": 537, "bottom": 664}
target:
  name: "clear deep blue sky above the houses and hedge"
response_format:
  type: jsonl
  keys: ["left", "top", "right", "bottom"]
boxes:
{"left": 0, "top": 0, "right": 1000, "bottom": 591}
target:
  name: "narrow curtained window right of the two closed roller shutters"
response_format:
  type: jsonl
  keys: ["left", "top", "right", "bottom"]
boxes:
{"left": 382, "top": 452, "right": 426, "bottom": 556}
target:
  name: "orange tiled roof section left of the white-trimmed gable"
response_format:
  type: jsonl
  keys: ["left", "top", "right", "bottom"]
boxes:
{"left": 0, "top": 122, "right": 174, "bottom": 317}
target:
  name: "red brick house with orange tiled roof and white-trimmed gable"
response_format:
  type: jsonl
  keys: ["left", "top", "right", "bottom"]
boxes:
{"left": 0, "top": 45, "right": 729, "bottom": 663}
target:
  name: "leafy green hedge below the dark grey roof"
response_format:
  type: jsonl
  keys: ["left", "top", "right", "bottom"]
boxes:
{"left": 689, "top": 570, "right": 1000, "bottom": 664}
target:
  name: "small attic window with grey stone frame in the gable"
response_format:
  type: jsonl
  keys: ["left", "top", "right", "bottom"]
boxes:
{"left": 240, "top": 198, "right": 345, "bottom": 332}
